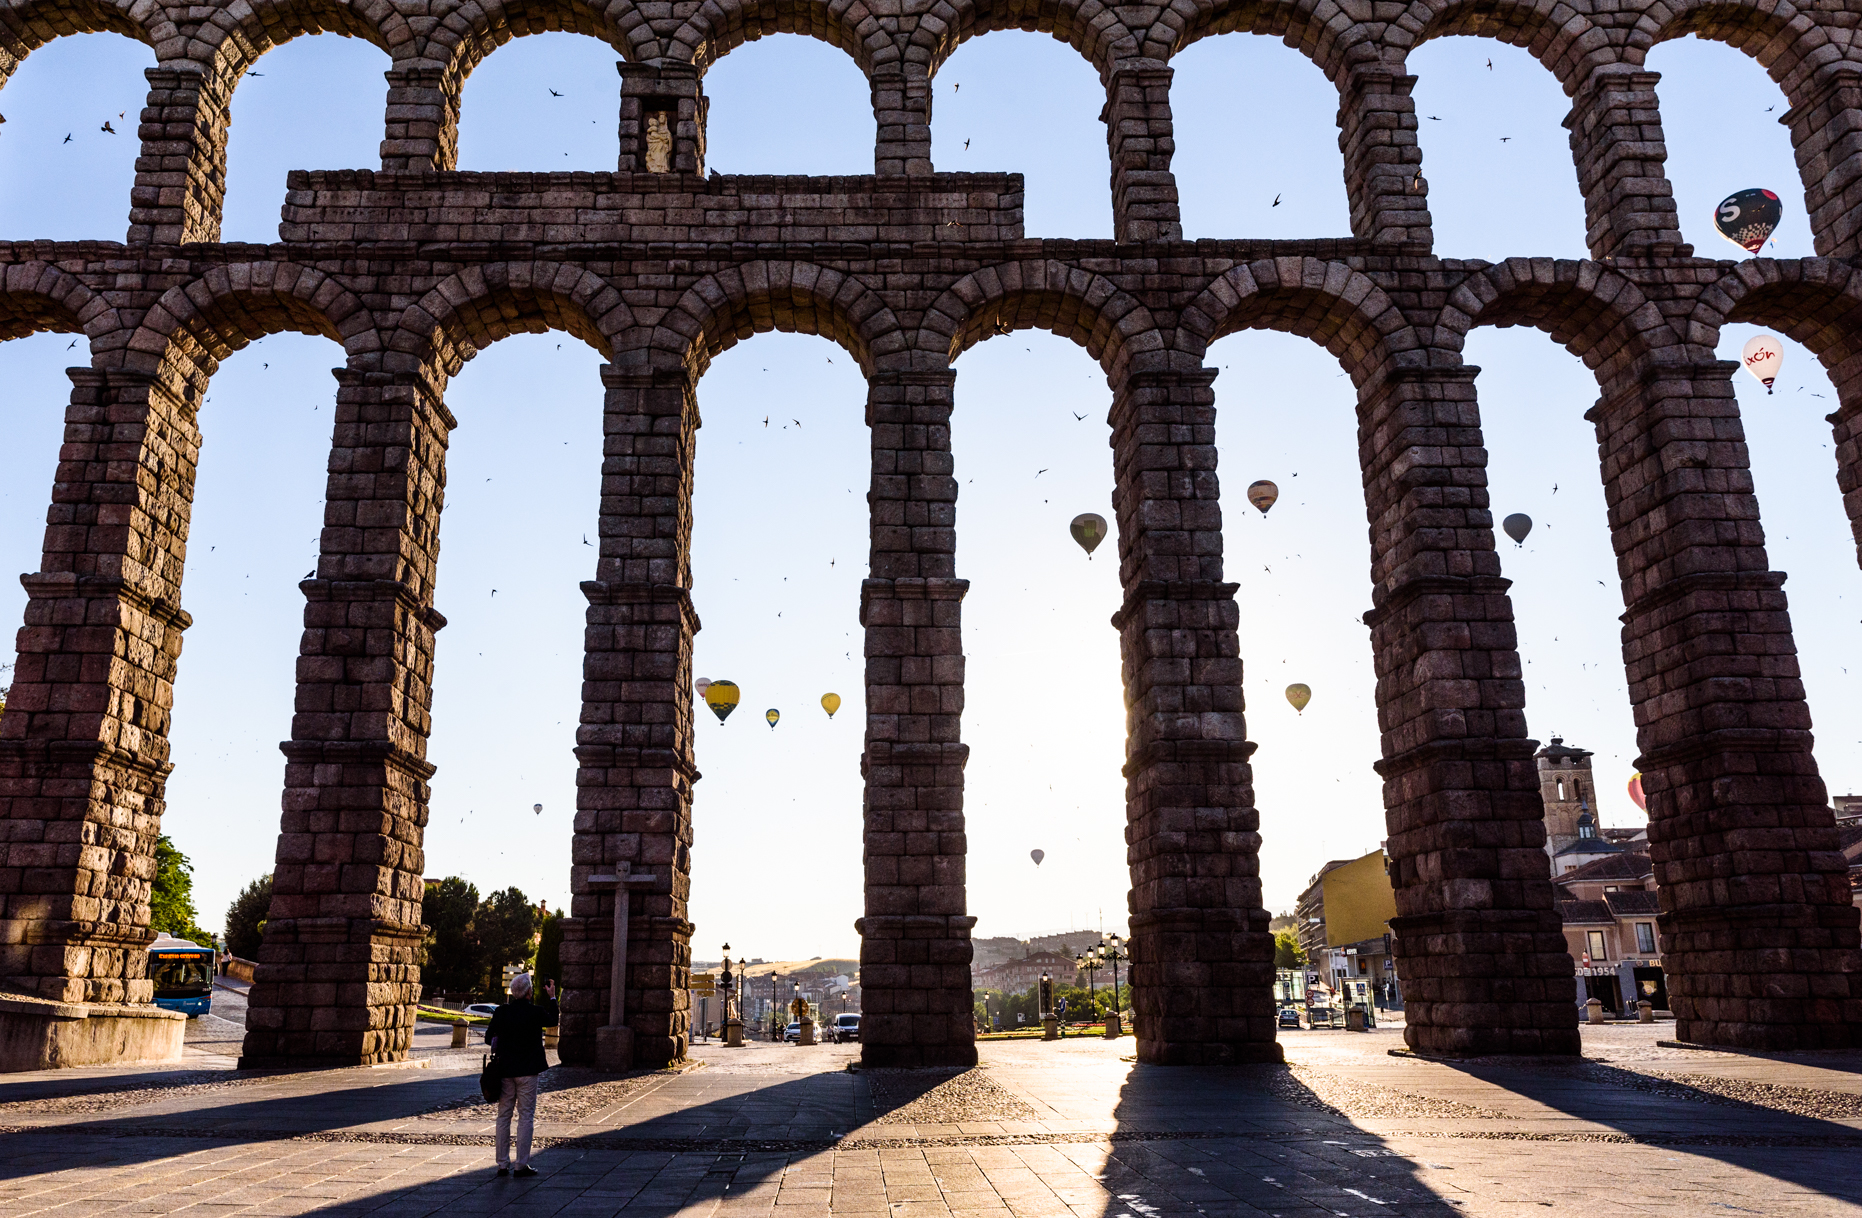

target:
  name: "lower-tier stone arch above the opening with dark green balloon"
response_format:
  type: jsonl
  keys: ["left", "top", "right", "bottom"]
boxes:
{"left": 920, "top": 261, "right": 1166, "bottom": 378}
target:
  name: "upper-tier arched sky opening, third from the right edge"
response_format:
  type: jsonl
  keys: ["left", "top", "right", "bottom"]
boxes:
{"left": 1171, "top": 34, "right": 1352, "bottom": 240}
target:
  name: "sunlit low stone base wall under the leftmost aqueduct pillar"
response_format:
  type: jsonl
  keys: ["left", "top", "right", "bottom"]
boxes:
{"left": 0, "top": 993, "right": 188, "bottom": 1075}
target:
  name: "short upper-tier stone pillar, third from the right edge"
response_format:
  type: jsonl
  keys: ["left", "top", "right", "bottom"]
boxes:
{"left": 1339, "top": 63, "right": 1436, "bottom": 253}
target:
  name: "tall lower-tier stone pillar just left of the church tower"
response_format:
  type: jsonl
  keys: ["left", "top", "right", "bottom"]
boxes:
{"left": 1357, "top": 367, "right": 1579, "bottom": 1054}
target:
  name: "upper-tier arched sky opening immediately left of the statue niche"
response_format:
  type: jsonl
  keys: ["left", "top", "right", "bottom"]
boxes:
{"left": 458, "top": 32, "right": 620, "bottom": 173}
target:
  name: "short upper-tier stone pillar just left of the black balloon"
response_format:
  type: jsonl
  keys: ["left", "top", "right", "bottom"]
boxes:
{"left": 1564, "top": 65, "right": 1693, "bottom": 259}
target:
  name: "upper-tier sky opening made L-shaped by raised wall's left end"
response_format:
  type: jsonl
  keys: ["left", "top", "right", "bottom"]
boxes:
{"left": 220, "top": 34, "right": 389, "bottom": 244}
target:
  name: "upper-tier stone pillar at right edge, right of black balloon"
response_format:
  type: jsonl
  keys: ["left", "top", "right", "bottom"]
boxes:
{"left": 1778, "top": 61, "right": 1862, "bottom": 259}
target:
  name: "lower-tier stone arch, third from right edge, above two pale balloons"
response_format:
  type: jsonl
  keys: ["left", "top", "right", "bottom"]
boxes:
{"left": 1177, "top": 257, "right": 1424, "bottom": 386}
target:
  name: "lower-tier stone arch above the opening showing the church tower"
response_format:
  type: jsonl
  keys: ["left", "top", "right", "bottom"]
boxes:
{"left": 1430, "top": 259, "right": 1678, "bottom": 382}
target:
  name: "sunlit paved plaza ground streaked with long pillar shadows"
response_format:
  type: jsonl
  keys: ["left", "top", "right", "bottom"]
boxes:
{"left": 0, "top": 1024, "right": 1862, "bottom": 1218}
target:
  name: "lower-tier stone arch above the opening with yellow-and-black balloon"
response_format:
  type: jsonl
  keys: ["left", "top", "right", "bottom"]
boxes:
{"left": 640, "top": 263, "right": 909, "bottom": 376}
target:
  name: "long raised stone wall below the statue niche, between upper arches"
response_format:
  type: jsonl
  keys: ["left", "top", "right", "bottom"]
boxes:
{"left": 277, "top": 169, "right": 1022, "bottom": 246}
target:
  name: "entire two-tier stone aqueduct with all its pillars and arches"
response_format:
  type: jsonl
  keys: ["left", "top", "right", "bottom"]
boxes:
{"left": 0, "top": 0, "right": 1862, "bottom": 1065}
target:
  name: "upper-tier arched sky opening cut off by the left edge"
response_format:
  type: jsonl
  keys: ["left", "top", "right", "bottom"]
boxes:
{"left": 0, "top": 34, "right": 155, "bottom": 240}
